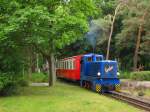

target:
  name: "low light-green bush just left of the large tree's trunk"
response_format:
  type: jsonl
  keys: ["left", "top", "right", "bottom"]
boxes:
{"left": 31, "top": 73, "right": 48, "bottom": 82}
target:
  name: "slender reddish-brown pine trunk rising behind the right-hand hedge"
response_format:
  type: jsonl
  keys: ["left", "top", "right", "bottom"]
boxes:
{"left": 133, "top": 11, "right": 147, "bottom": 71}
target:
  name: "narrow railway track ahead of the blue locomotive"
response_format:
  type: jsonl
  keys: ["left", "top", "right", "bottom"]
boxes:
{"left": 106, "top": 91, "right": 150, "bottom": 112}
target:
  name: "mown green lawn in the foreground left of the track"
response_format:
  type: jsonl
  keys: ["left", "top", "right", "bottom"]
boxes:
{"left": 0, "top": 82, "right": 144, "bottom": 112}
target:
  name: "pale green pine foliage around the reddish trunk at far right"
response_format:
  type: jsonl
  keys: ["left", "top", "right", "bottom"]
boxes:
{"left": 116, "top": 0, "right": 150, "bottom": 70}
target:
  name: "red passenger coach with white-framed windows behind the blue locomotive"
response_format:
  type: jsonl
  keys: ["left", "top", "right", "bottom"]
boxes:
{"left": 56, "top": 55, "right": 82, "bottom": 81}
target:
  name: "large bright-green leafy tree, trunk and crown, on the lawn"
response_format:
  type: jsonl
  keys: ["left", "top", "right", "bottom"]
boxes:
{"left": 0, "top": 0, "right": 96, "bottom": 86}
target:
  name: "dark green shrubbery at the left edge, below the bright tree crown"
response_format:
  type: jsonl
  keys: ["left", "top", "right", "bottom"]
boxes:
{"left": 0, "top": 34, "right": 24, "bottom": 96}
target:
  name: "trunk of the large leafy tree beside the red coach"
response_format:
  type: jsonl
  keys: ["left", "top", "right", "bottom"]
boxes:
{"left": 47, "top": 54, "right": 56, "bottom": 86}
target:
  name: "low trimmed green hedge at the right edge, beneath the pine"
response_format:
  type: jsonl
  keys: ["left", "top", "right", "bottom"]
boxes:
{"left": 131, "top": 71, "right": 150, "bottom": 81}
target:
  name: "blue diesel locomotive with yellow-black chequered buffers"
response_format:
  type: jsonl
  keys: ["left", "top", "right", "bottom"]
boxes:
{"left": 80, "top": 54, "right": 120, "bottom": 92}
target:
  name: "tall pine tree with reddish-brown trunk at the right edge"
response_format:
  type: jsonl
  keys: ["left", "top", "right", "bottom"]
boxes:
{"left": 118, "top": 0, "right": 150, "bottom": 71}
